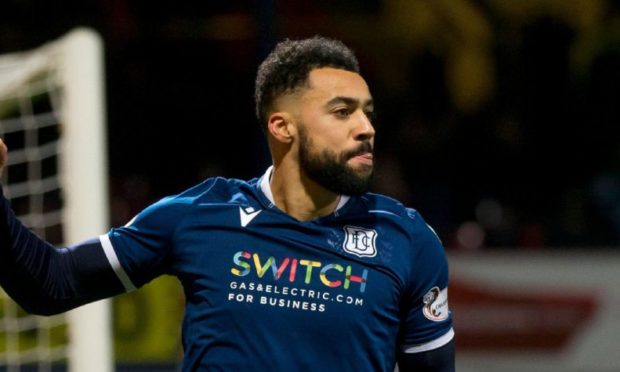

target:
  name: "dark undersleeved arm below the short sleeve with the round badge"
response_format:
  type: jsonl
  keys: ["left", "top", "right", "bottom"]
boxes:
{"left": 398, "top": 339, "right": 455, "bottom": 372}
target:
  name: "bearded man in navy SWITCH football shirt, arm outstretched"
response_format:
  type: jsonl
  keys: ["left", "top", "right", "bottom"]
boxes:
{"left": 0, "top": 37, "right": 454, "bottom": 371}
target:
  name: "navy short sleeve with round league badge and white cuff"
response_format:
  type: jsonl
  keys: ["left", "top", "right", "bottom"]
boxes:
{"left": 400, "top": 209, "right": 454, "bottom": 353}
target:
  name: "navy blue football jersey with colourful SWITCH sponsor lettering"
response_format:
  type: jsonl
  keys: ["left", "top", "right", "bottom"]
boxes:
{"left": 100, "top": 168, "right": 453, "bottom": 371}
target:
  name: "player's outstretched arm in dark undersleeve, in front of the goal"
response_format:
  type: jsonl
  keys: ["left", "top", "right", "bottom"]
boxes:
{"left": 0, "top": 139, "right": 124, "bottom": 315}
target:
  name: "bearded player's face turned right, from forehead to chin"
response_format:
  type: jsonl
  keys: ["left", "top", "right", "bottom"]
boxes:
{"left": 298, "top": 68, "right": 375, "bottom": 195}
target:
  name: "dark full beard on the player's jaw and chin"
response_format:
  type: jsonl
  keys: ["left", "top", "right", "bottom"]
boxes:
{"left": 299, "top": 128, "right": 373, "bottom": 196}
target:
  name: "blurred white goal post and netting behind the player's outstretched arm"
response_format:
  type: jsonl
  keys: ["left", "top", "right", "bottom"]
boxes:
{"left": 0, "top": 29, "right": 113, "bottom": 372}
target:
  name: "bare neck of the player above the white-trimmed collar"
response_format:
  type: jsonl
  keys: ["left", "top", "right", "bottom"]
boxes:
{"left": 270, "top": 163, "right": 340, "bottom": 221}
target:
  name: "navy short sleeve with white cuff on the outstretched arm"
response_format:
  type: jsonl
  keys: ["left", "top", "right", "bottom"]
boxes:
{"left": 100, "top": 197, "right": 183, "bottom": 290}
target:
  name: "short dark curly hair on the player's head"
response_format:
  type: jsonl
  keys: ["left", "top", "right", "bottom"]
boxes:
{"left": 254, "top": 36, "right": 359, "bottom": 130}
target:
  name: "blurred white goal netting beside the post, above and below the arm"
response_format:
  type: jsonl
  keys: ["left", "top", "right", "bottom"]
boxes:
{"left": 0, "top": 50, "right": 68, "bottom": 371}
